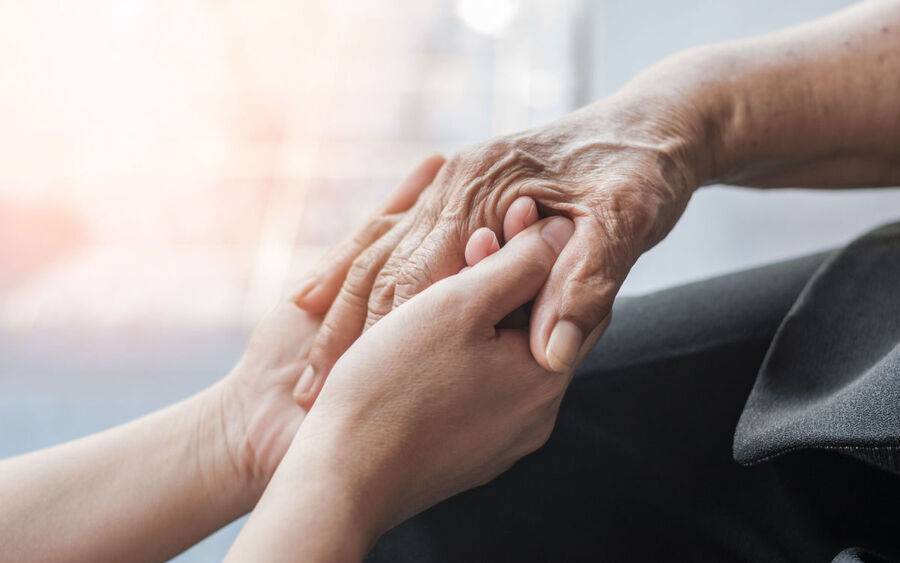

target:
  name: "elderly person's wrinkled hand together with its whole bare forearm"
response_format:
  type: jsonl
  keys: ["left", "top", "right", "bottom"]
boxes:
{"left": 297, "top": 1, "right": 900, "bottom": 405}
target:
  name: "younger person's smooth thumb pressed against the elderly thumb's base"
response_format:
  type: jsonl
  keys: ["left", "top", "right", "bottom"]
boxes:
{"left": 453, "top": 217, "right": 575, "bottom": 326}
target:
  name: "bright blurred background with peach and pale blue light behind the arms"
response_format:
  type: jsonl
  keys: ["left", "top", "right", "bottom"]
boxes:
{"left": 0, "top": 0, "right": 900, "bottom": 561}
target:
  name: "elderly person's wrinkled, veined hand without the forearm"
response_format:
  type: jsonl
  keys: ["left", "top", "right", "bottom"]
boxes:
{"left": 296, "top": 100, "right": 700, "bottom": 405}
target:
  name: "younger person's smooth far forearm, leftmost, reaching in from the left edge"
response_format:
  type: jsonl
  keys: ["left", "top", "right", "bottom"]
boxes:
{"left": 0, "top": 388, "right": 253, "bottom": 561}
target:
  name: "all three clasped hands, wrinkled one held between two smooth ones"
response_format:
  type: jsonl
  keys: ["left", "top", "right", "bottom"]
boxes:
{"left": 220, "top": 108, "right": 694, "bottom": 555}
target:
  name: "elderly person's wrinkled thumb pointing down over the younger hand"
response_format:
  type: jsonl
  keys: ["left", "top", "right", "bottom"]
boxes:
{"left": 530, "top": 218, "right": 633, "bottom": 372}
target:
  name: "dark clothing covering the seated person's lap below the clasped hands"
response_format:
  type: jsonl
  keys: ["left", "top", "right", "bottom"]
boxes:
{"left": 369, "top": 223, "right": 900, "bottom": 562}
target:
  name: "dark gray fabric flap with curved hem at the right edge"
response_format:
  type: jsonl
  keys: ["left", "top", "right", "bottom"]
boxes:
{"left": 734, "top": 223, "right": 900, "bottom": 474}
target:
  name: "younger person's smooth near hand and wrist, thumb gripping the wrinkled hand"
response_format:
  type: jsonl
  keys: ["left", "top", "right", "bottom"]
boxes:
{"left": 227, "top": 217, "right": 574, "bottom": 561}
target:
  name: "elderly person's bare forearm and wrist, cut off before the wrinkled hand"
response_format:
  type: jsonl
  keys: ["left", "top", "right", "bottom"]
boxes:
{"left": 613, "top": 0, "right": 900, "bottom": 187}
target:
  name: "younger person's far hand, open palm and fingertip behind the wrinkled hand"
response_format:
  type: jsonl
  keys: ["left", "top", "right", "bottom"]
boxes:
{"left": 214, "top": 155, "right": 443, "bottom": 502}
